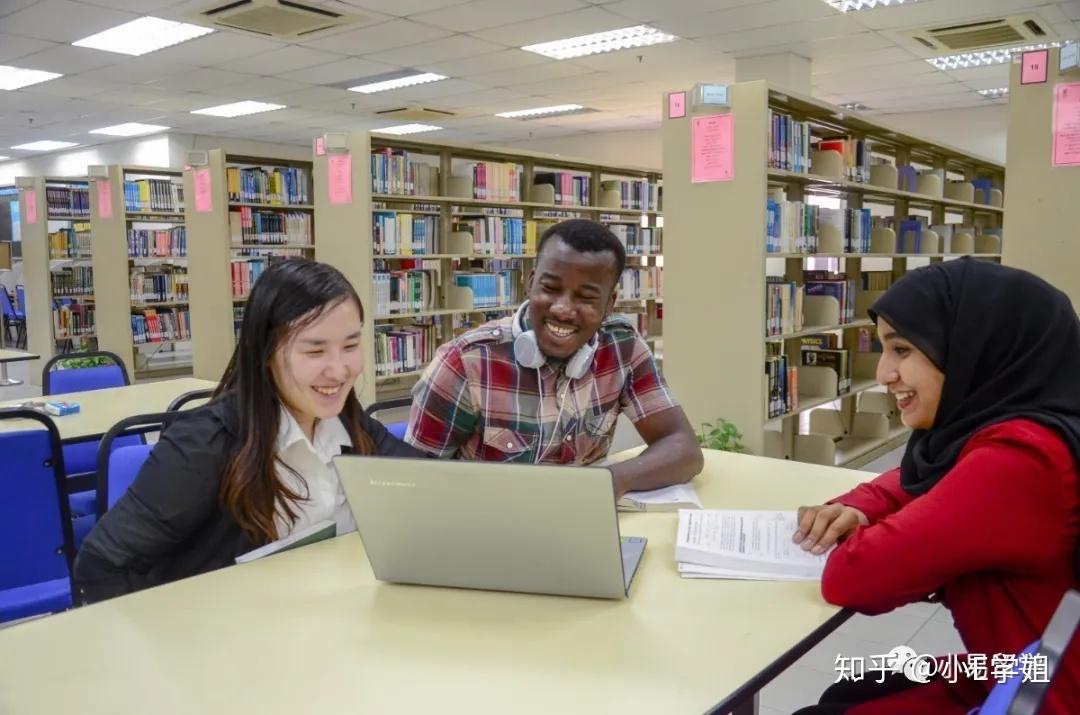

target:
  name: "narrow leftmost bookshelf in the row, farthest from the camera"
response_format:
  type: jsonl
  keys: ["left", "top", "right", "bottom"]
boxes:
{"left": 16, "top": 176, "right": 94, "bottom": 382}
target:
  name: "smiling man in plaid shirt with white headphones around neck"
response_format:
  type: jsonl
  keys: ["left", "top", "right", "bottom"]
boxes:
{"left": 405, "top": 218, "right": 702, "bottom": 496}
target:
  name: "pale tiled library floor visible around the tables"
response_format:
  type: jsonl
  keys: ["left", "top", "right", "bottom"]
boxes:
{"left": 0, "top": 364, "right": 963, "bottom": 715}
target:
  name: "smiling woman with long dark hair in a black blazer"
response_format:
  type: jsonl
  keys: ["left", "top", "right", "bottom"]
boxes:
{"left": 75, "top": 259, "right": 421, "bottom": 603}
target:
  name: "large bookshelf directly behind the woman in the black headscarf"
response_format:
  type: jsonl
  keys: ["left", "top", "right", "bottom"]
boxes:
{"left": 662, "top": 82, "right": 1007, "bottom": 467}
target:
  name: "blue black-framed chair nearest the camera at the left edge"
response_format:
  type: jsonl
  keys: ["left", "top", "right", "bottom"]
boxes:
{"left": 0, "top": 408, "right": 75, "bottom": 623}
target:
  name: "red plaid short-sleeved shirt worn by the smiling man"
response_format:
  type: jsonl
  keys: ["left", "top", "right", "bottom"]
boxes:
{"left": 405, "top": 316, "right": 678, "bottom": 464}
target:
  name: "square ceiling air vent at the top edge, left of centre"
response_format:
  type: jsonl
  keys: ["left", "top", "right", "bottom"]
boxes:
{"left": 192, "top": 0, "right": 368, "bottom": 40}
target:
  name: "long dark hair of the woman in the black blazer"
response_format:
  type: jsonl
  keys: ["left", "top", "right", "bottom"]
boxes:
{"left": 214, "top": 258, "right": 374, "bottom": 543}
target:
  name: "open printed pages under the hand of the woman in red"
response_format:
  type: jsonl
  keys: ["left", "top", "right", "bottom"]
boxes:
{"left": 675, "top": 509, "right": 827, "bottom": 581}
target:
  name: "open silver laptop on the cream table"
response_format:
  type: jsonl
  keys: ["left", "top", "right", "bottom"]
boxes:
{"left": 334, "top": 456, "right": 646, "bottom": 598}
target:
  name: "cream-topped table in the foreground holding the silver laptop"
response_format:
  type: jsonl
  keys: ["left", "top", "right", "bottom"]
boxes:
{"left": 0, "top": 451, "right": 865, "bottom": 715}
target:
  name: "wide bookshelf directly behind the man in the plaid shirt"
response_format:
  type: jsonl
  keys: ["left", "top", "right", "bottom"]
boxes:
{"left": 314, "top": 133, "right": 663, "bottom": 404}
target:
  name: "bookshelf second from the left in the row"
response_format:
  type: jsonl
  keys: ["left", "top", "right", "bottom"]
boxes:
{"left": 89, "top": 165, "right": 193, "bottom": 378}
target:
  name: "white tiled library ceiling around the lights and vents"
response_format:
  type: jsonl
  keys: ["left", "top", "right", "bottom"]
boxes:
{"left": 0, "top": 0, "right": 1080, "bottom": 159}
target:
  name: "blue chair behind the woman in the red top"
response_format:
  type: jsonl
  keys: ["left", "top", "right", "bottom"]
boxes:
{"left": 968, "top": 591, "right": 1080, "bottom": 715}
